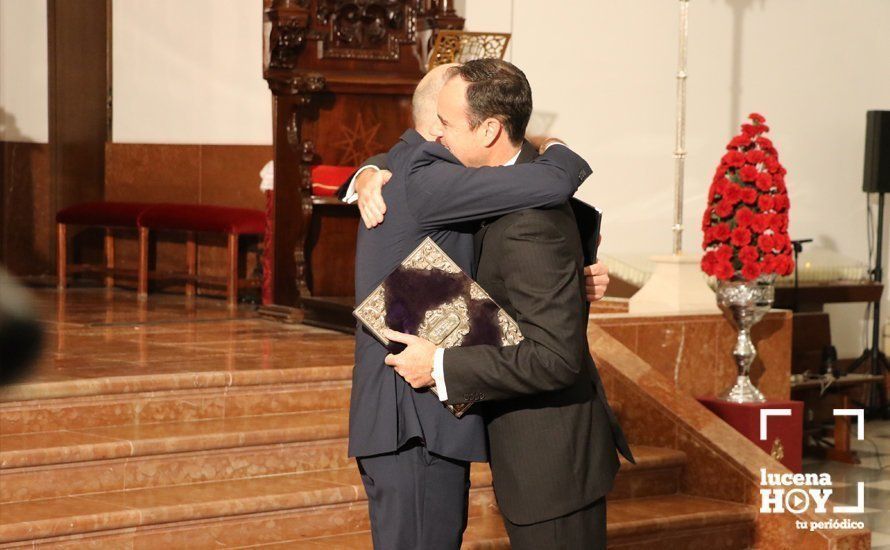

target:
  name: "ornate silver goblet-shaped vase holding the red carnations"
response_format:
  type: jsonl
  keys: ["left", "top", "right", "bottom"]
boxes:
{"left": 717, "top": 274, "right": 776, "bottom": 403}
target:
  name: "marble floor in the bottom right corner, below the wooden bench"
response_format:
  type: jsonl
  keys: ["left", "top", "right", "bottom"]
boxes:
{"left": 803, "top": 420, "right": 890, "bottom": 550}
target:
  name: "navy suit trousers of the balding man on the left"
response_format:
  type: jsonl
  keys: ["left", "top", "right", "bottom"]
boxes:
{"left": 356, "top": 438, "right": 470, "bottom": 550}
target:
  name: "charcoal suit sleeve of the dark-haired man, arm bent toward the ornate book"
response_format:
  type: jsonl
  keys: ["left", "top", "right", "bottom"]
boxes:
{"left": 443, "top": 211, "right": 587, "bottom": 405}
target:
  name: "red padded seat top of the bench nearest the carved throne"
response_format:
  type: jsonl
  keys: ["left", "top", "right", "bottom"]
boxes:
{"left": 139, "top": 203, "right": 266, "bottom": 234}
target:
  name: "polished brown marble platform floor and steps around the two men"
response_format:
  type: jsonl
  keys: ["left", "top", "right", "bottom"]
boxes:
{"left": 0, "top": 288, "right": 756, "bottom": 549}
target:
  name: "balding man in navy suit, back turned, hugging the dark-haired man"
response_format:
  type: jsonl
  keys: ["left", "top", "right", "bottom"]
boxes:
{"left": 349, "top": 61, "right": 590, "bottom": 550}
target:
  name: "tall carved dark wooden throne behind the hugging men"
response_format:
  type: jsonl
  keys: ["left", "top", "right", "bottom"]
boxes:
{"left": 263, "top": 0, "right": 463, "bottom": 330}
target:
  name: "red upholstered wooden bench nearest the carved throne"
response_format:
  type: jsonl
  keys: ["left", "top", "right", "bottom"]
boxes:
{"left": 138, "top": 207, "right": 266, "bottom": 307}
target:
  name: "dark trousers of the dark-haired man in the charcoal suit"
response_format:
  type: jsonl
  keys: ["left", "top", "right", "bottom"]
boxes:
{"left": 504, "top": 496, "right": 606, "bottom": 550}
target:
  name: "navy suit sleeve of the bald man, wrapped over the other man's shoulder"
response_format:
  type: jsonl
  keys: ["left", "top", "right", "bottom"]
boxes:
{"left": 406, "top": 142, "right": 590, "bottom": 228}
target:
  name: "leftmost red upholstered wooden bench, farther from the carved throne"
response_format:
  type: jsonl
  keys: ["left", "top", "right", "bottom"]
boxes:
{"left": 56, "top": 202, "right": 150, "bottom": 289}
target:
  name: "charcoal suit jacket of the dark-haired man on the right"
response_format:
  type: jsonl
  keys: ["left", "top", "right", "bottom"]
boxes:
{"left": 443, "top": 141, "right": 633, "bottom": 524}
